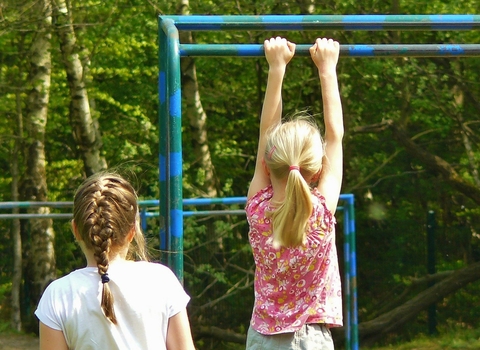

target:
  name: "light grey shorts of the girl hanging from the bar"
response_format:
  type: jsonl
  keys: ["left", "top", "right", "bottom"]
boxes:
{"left": 246, "top": 324, "right": 334, "bottom": 350}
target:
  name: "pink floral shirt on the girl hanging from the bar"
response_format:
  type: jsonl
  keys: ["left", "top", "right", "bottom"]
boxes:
{"left": 246, "top": 186, "right": 342, "bottom": 335}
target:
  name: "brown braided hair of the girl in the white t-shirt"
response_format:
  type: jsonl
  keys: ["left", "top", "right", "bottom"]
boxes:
{"left": 73, "top": 172, "right": 148, "bottom": 324}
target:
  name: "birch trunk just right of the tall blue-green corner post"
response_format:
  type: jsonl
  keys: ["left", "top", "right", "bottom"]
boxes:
{"left": 177, "top": 0, "right": 218, "bottom": 197}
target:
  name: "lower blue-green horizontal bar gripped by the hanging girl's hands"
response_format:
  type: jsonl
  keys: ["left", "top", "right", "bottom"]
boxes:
{"left": 180, "top": 44, "right": 480, "bottom": 57}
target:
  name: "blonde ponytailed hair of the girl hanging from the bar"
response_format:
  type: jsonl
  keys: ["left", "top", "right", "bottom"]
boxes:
{"left": 265, "top": 117, "right": 324, "bottom": 247}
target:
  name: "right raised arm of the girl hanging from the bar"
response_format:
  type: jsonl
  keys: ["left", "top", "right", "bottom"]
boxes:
{"left": 310, "top": 39, "right": 343, "bottom": 213}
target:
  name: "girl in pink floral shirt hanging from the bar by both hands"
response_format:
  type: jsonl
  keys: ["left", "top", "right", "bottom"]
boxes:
{"left": 246, "top": 37, "right": 343, "bottom": 350}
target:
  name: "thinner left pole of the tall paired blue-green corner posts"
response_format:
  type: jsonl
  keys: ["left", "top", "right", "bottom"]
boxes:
{"left": 158, "top": 17, "right": 172, "bottom": 265}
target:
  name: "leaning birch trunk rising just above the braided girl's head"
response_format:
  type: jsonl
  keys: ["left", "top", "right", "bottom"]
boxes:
{"left": 54, "top": 0, "right": 107, "bottom": 176}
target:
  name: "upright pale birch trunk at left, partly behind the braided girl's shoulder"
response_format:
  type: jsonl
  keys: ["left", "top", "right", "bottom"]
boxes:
{"left": 22, "top": 0, "right": 55, "bottom": 331}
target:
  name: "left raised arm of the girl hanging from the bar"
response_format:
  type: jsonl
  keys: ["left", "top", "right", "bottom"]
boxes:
{"left": 248, "top": 37, "right": 295, "bottom": 198}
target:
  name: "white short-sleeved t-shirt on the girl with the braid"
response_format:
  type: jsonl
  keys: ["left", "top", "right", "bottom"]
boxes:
{"left": 35, "top": 259, "right": 190, "bottom": 350}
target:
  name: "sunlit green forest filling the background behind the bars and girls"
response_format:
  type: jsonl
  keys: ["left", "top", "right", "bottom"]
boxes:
{"left": 0, "top": 0, "right": 480, "bottom": 349}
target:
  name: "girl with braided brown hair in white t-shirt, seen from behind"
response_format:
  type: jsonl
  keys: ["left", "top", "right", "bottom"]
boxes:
{"left": 35, "top": 173, "right": 195, "bottom": 350}
